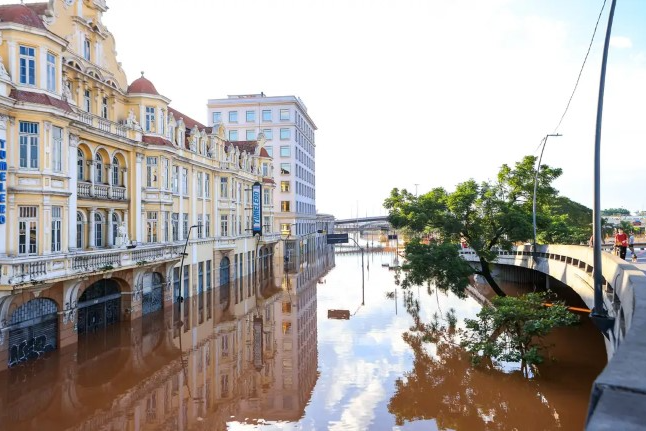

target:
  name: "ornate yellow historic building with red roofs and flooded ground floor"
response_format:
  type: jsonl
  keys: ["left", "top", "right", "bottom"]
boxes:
{"left": 0, "top": 0, "right": 280, "bottom": 369}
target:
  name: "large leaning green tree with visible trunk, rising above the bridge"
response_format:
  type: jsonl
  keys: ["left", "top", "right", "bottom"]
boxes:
{"left": 384, "top": 156, "right": 562, "bottom": 296}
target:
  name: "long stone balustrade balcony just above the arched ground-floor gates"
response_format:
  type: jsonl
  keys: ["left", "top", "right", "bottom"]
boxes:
{"left": 0, "top": 244, "right": 183, "bottom": 290}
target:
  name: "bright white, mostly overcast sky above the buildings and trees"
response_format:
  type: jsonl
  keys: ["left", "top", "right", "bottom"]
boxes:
{"left": 4, "top": 0, "right": 646, "bottom": 217}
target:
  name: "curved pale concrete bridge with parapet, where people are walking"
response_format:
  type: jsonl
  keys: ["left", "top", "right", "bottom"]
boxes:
{"left": 461, "top": 245, "right": 646, "bottom": 431}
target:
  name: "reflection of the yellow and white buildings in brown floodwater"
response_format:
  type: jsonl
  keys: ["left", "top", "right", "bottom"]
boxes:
{"left": 0, "top": 250, "right": 333, "bottom": 431}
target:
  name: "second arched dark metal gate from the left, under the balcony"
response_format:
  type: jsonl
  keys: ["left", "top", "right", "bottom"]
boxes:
{"left": 77, "top": 280, "right": 121, "bottom": 334}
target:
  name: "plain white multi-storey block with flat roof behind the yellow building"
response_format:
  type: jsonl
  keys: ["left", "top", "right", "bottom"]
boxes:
{"left": 207, "top": 93, "right": 320, "bottom": 264}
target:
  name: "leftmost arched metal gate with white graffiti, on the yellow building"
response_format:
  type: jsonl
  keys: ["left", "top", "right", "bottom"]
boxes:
{"left": 8, "top": 298, "right": 58, "bottom": 367}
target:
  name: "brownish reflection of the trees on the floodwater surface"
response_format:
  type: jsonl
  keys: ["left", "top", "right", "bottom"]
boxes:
{"left": 388, "top": 292, "right": 568, "bottom": 430}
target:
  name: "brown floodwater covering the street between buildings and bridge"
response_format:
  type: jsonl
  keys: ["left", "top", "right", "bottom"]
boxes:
{"left": 0, "top": 253, "right": 606, "bottom": 431}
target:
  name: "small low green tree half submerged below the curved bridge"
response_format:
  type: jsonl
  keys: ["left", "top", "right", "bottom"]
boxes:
{"left": 462, "top": 293, "right": 578, "bottom": 375}
